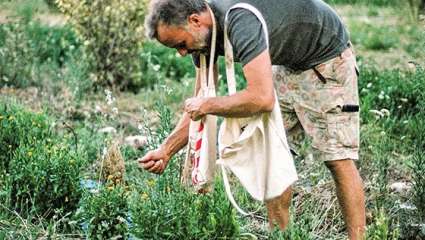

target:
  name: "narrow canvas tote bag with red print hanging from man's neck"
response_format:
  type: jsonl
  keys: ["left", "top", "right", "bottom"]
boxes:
{"left": 181, "top": 5, "right": 217, "bottom": 193}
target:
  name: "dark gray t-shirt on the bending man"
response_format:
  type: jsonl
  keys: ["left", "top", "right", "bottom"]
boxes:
{"left": 193, "top": 0, "right": 349, "bottom": 70}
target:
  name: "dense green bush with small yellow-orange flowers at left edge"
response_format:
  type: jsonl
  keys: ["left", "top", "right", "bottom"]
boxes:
{"left": 0, "top": 104, "right": 82, "bottom": 218}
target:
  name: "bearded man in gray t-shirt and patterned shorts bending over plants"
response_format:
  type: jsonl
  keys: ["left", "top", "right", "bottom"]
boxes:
{"left": 139, "top": 0, "right": 365, "bottom": 239}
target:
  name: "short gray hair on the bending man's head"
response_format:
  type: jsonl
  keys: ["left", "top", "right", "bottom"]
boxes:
{"left": 145, "top": 0, "right": 207, "bottom": 39}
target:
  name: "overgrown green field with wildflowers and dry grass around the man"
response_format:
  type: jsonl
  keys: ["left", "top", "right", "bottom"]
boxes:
{"left": 0, "top": 0, "right": 425, "bottom": 240}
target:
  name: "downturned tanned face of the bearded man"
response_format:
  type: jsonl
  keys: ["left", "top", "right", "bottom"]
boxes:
{"left": 158, "top": 21, "right": 211, "bottom": 56}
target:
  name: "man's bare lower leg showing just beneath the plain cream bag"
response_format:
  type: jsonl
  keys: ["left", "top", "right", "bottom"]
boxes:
{"left": 266, "top": 187, "right": 292, "bottom": 230}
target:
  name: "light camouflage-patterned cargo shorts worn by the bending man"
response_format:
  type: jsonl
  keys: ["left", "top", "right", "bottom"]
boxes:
{"left": 273, "top": 48, "right": 359, "bottom": 161}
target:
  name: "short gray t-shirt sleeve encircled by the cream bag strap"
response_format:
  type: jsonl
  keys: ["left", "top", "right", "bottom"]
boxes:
{"left": 228, "top": 8, "right": 267, "bottom": 66}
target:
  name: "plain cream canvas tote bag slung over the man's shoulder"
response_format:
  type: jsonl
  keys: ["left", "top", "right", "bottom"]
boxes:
{"left": 217, "top": 3, "right": 298, "bottom": 208}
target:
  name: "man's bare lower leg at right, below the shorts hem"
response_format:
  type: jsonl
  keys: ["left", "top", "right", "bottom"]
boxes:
{"left": 325, "top": 159, "right": 366, "bottom": 240}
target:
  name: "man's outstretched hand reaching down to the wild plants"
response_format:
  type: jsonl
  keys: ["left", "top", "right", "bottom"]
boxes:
{"left": 137, "top": 147, "right": 171, "bottom": 174}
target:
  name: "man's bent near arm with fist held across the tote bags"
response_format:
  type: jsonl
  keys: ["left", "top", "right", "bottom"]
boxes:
{"left": 185, "top": 50, "right": 275, "bottom": 119}
